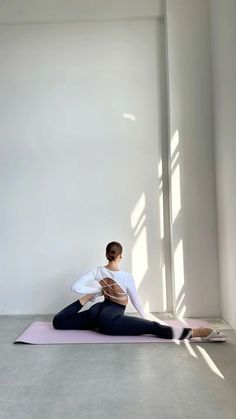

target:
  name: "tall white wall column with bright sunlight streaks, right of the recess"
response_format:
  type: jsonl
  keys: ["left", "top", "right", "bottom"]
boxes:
{"left": 166, "top": 0, "right": 220, "bottom": 316}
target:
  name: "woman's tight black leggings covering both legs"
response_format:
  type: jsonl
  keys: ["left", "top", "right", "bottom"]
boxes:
{"left": 52, "top": 300, "right": 192, "bottom": 339}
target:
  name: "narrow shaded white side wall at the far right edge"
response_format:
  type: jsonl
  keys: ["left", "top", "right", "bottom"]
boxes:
{"left": 209, "top": 0, "right": 236, "bottom": 328}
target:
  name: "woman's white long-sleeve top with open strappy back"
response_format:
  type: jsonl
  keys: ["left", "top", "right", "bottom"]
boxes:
{"left": 71, "top": 266, "right": 147, "bottom": 319}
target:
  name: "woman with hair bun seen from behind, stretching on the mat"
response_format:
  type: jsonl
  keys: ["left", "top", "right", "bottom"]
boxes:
{"left": 52, "top": 242, "right": 226, "bottom": 342}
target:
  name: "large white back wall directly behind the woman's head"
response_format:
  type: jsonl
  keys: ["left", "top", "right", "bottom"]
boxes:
{"left": 0, "top": 14, "right": 168, "bottom": 314}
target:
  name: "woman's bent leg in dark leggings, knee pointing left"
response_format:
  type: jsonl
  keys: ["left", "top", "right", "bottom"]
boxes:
{"left": 52, "top": 296, "right": 93, "bottom": 330}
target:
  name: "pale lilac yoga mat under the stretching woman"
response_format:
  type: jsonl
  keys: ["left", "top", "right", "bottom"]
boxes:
{"left": 13, "top": 319, "right": 211, "bottom": 345}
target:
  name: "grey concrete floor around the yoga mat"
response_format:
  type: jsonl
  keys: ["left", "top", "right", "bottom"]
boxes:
{"left": 0, "top": 315, "right": 236, "bottom": 419}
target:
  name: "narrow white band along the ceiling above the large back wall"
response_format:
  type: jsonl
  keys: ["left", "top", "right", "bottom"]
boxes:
{"left": 0, "top": 0, "right": 163, "bottom": 24}
